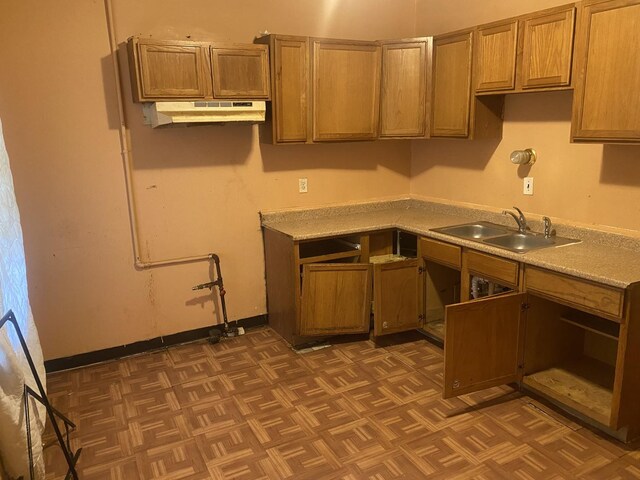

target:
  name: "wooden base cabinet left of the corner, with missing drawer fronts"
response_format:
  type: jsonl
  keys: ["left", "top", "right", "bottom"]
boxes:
{"left": 264, "top": 229, "right": 421, "bottom": 346}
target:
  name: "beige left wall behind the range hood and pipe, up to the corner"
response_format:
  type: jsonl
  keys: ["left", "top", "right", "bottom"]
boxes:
{"left": 0, "top": 0, "right": 415, "bottom": 359}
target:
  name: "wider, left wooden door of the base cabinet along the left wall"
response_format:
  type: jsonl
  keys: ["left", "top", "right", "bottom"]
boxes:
{"left": 300, "top": 263, "right": 373, "bottom": 335}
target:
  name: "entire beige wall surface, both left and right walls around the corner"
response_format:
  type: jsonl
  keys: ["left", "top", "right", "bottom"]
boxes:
{"left": 0, "top": 0, "right": 640, "bottom": 359}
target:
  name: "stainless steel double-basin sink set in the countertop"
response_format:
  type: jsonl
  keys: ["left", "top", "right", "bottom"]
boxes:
{"left": 432, "top": 222, "right": 580, "bottom": 253}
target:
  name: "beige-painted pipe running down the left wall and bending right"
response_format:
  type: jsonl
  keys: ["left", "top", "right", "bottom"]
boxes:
{"left": 104, "top": 0, "right": 210, "bottom": 268}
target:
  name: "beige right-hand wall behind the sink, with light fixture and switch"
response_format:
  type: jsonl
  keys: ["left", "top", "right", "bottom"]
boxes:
{"left": 411, "top": 0, "right": 640, "bottom": 234}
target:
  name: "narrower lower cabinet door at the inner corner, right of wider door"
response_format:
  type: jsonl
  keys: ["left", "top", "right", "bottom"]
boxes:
{"left": 373, "top": 258, "right": 420, "bottom": 336}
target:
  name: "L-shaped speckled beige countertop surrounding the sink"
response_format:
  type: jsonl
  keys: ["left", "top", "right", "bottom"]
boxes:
{"left": 261, "top": 199, "right": 640, "bottom": 288}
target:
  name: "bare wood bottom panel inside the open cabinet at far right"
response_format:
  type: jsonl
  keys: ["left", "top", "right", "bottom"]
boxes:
{"left": 522, "top": 357, "right": 615, "bottom": 425}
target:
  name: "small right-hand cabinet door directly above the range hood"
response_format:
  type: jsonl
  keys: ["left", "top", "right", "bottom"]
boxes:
{"left": 211, "top": 43, "right": 270, "bottom": 99}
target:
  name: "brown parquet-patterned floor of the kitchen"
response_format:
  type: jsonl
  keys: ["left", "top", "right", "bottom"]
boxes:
{"left": 45, "top": 327, "right": 640, "bottom": 480}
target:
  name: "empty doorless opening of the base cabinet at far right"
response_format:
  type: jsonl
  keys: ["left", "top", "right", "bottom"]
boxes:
{"left": 523, "top": 296, "right": 620, "bottom": 425}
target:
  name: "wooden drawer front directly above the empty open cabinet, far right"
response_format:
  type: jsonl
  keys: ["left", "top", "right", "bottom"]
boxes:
{"left": 524, "top": 267, "right": 624, "bottom": 322}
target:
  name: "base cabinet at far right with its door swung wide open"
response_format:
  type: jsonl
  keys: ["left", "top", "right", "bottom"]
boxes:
{"left": 444, "top": 268, "right": 640, "bottom": 441}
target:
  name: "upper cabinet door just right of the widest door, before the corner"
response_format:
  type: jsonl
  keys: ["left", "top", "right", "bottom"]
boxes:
{"left": 380, "top": 39, "right": 430, "bottom": 138}
